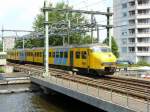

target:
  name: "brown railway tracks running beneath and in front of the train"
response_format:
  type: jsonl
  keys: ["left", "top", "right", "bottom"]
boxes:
{"left": 10, "top": 63, "right": 150, "bottom": 100}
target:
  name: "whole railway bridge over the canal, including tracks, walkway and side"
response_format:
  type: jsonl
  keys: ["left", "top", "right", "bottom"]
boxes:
{"left": 13, "top": 64, "right": 150, "bottom": 112}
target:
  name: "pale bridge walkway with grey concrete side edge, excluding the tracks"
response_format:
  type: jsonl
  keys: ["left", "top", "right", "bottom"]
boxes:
{"left": 31, "top": 75, "right": 150, "bottom": 112}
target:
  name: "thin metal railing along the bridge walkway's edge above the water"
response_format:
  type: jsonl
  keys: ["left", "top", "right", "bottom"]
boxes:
{"left": 32, "top": 74, "right": 150, "bottom": 112}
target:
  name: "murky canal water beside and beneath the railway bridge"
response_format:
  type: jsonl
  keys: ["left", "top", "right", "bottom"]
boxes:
{"left": 0, "top": 85, "right": 104, "bottom": 112}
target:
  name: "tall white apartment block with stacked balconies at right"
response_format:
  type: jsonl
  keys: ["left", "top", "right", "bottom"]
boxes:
{"left": 113, "top": 0, "right": 150, "bottom": 63}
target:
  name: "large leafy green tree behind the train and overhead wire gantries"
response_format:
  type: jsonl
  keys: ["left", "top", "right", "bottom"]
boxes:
{"left": 16, "top": 2, "right": 90, "bottom": 47}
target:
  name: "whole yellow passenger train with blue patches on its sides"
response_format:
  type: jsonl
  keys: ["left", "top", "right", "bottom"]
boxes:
{"left": 7, "top": 44, "right": 116, "bottom": 75}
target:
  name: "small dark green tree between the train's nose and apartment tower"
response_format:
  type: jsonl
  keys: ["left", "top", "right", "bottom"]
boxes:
{"left": 103, "top": 37, "right": 119, "bottom": 58}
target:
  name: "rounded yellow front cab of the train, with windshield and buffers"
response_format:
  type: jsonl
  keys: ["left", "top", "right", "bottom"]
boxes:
{"left": 89, "top": 46, "right": 116, "bottom": 75}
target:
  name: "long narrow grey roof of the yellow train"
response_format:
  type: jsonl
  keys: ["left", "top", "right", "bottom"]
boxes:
{"left": 8, "top": 43, "right": 108, "bottom": 51}
